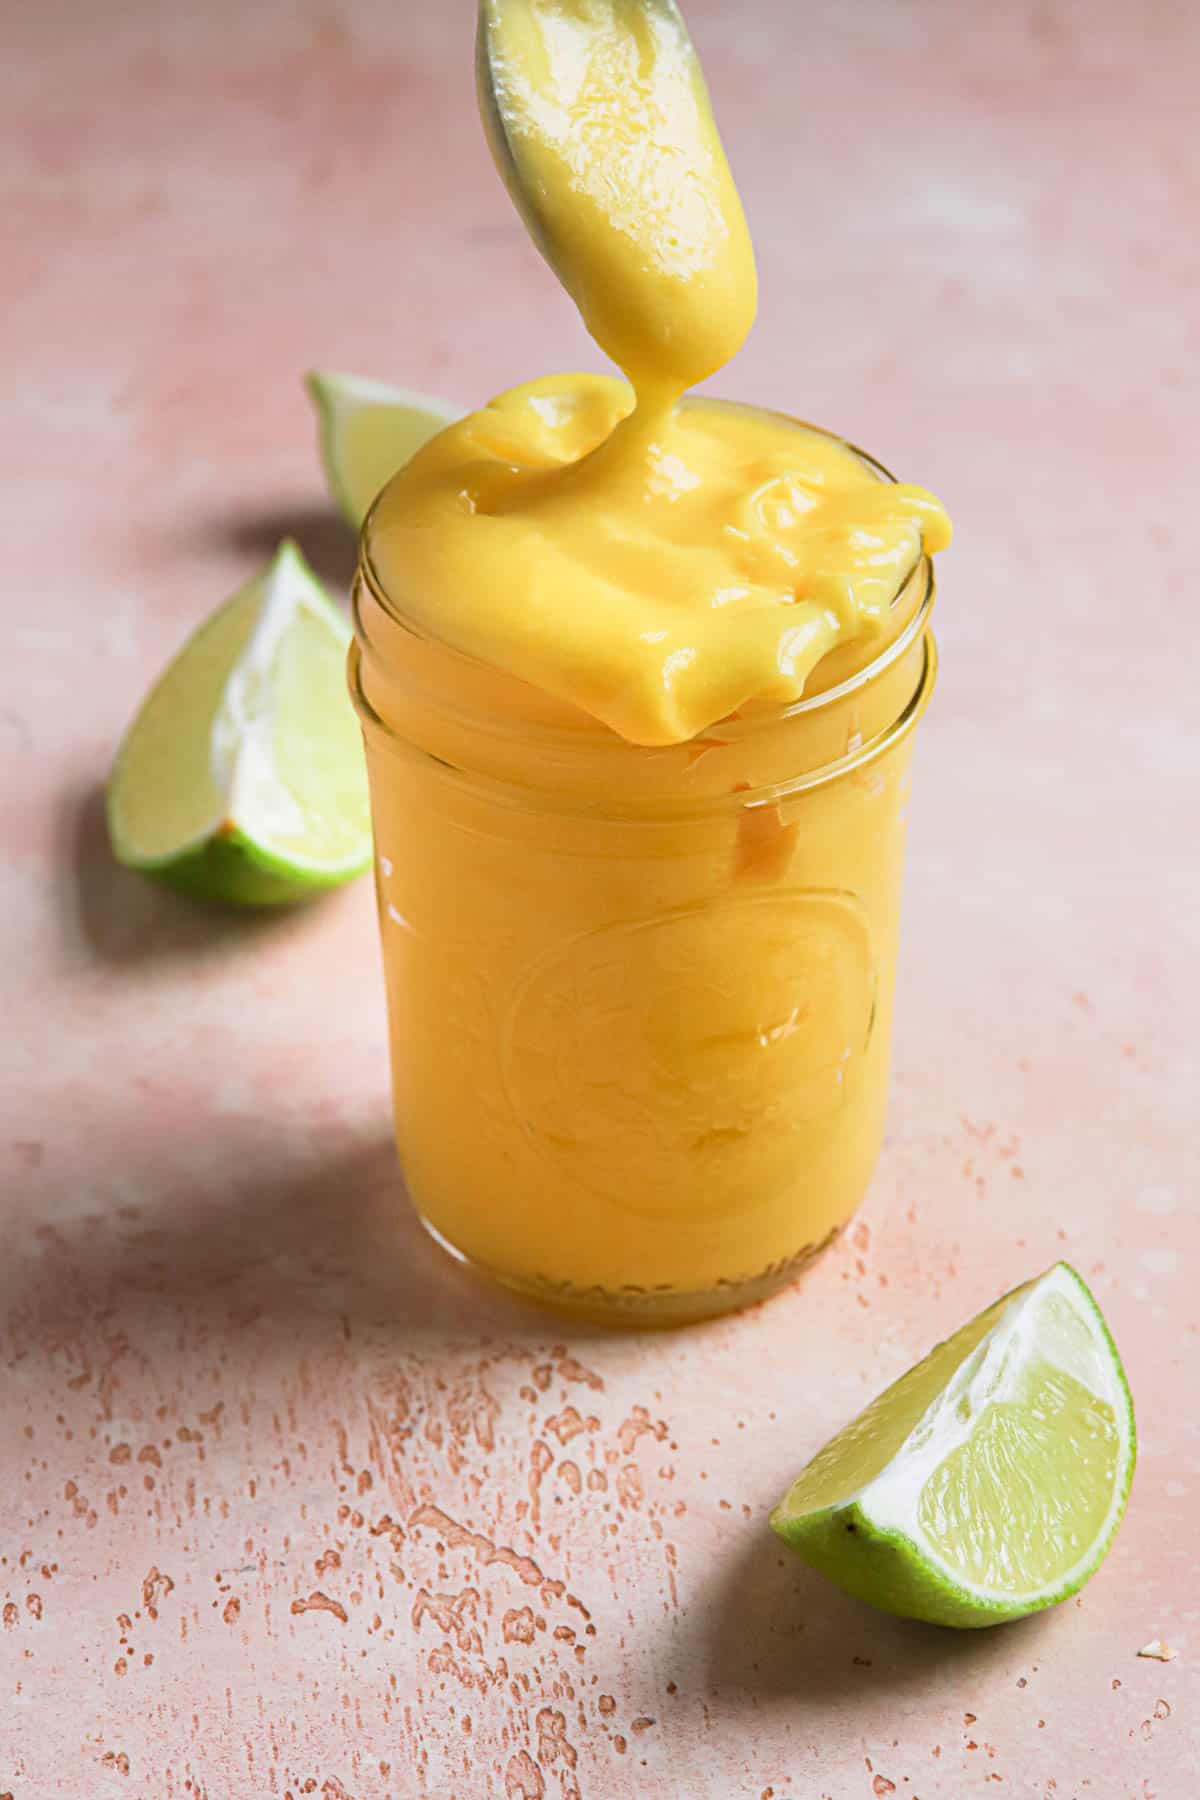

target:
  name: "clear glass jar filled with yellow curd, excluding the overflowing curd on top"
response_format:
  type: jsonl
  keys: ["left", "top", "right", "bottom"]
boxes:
{"left": 351, "top": 417, "right": 936, "bottom": 1323}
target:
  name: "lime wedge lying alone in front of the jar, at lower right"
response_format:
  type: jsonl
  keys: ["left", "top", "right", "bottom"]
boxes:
{"left": 770, "top": 1262, "right": 1137, "bottom": 1625}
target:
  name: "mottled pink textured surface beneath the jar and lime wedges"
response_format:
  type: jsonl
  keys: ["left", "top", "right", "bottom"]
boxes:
{"left": 0, "top": 0, "right": 1200, "bottom": 1800}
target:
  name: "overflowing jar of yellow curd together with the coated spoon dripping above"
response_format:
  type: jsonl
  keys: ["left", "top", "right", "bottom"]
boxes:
{"left": 351, "top": 0, "right": 948, "bottom": 1323}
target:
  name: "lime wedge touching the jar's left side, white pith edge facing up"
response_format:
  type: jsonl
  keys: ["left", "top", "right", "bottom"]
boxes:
{"left": 108, "top": 529, "right": 371, "bottom": 905}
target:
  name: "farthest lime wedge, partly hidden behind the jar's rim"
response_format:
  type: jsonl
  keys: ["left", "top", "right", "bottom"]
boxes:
{"left": 306, "top": 369, "right": 462, "bottom": 531}
